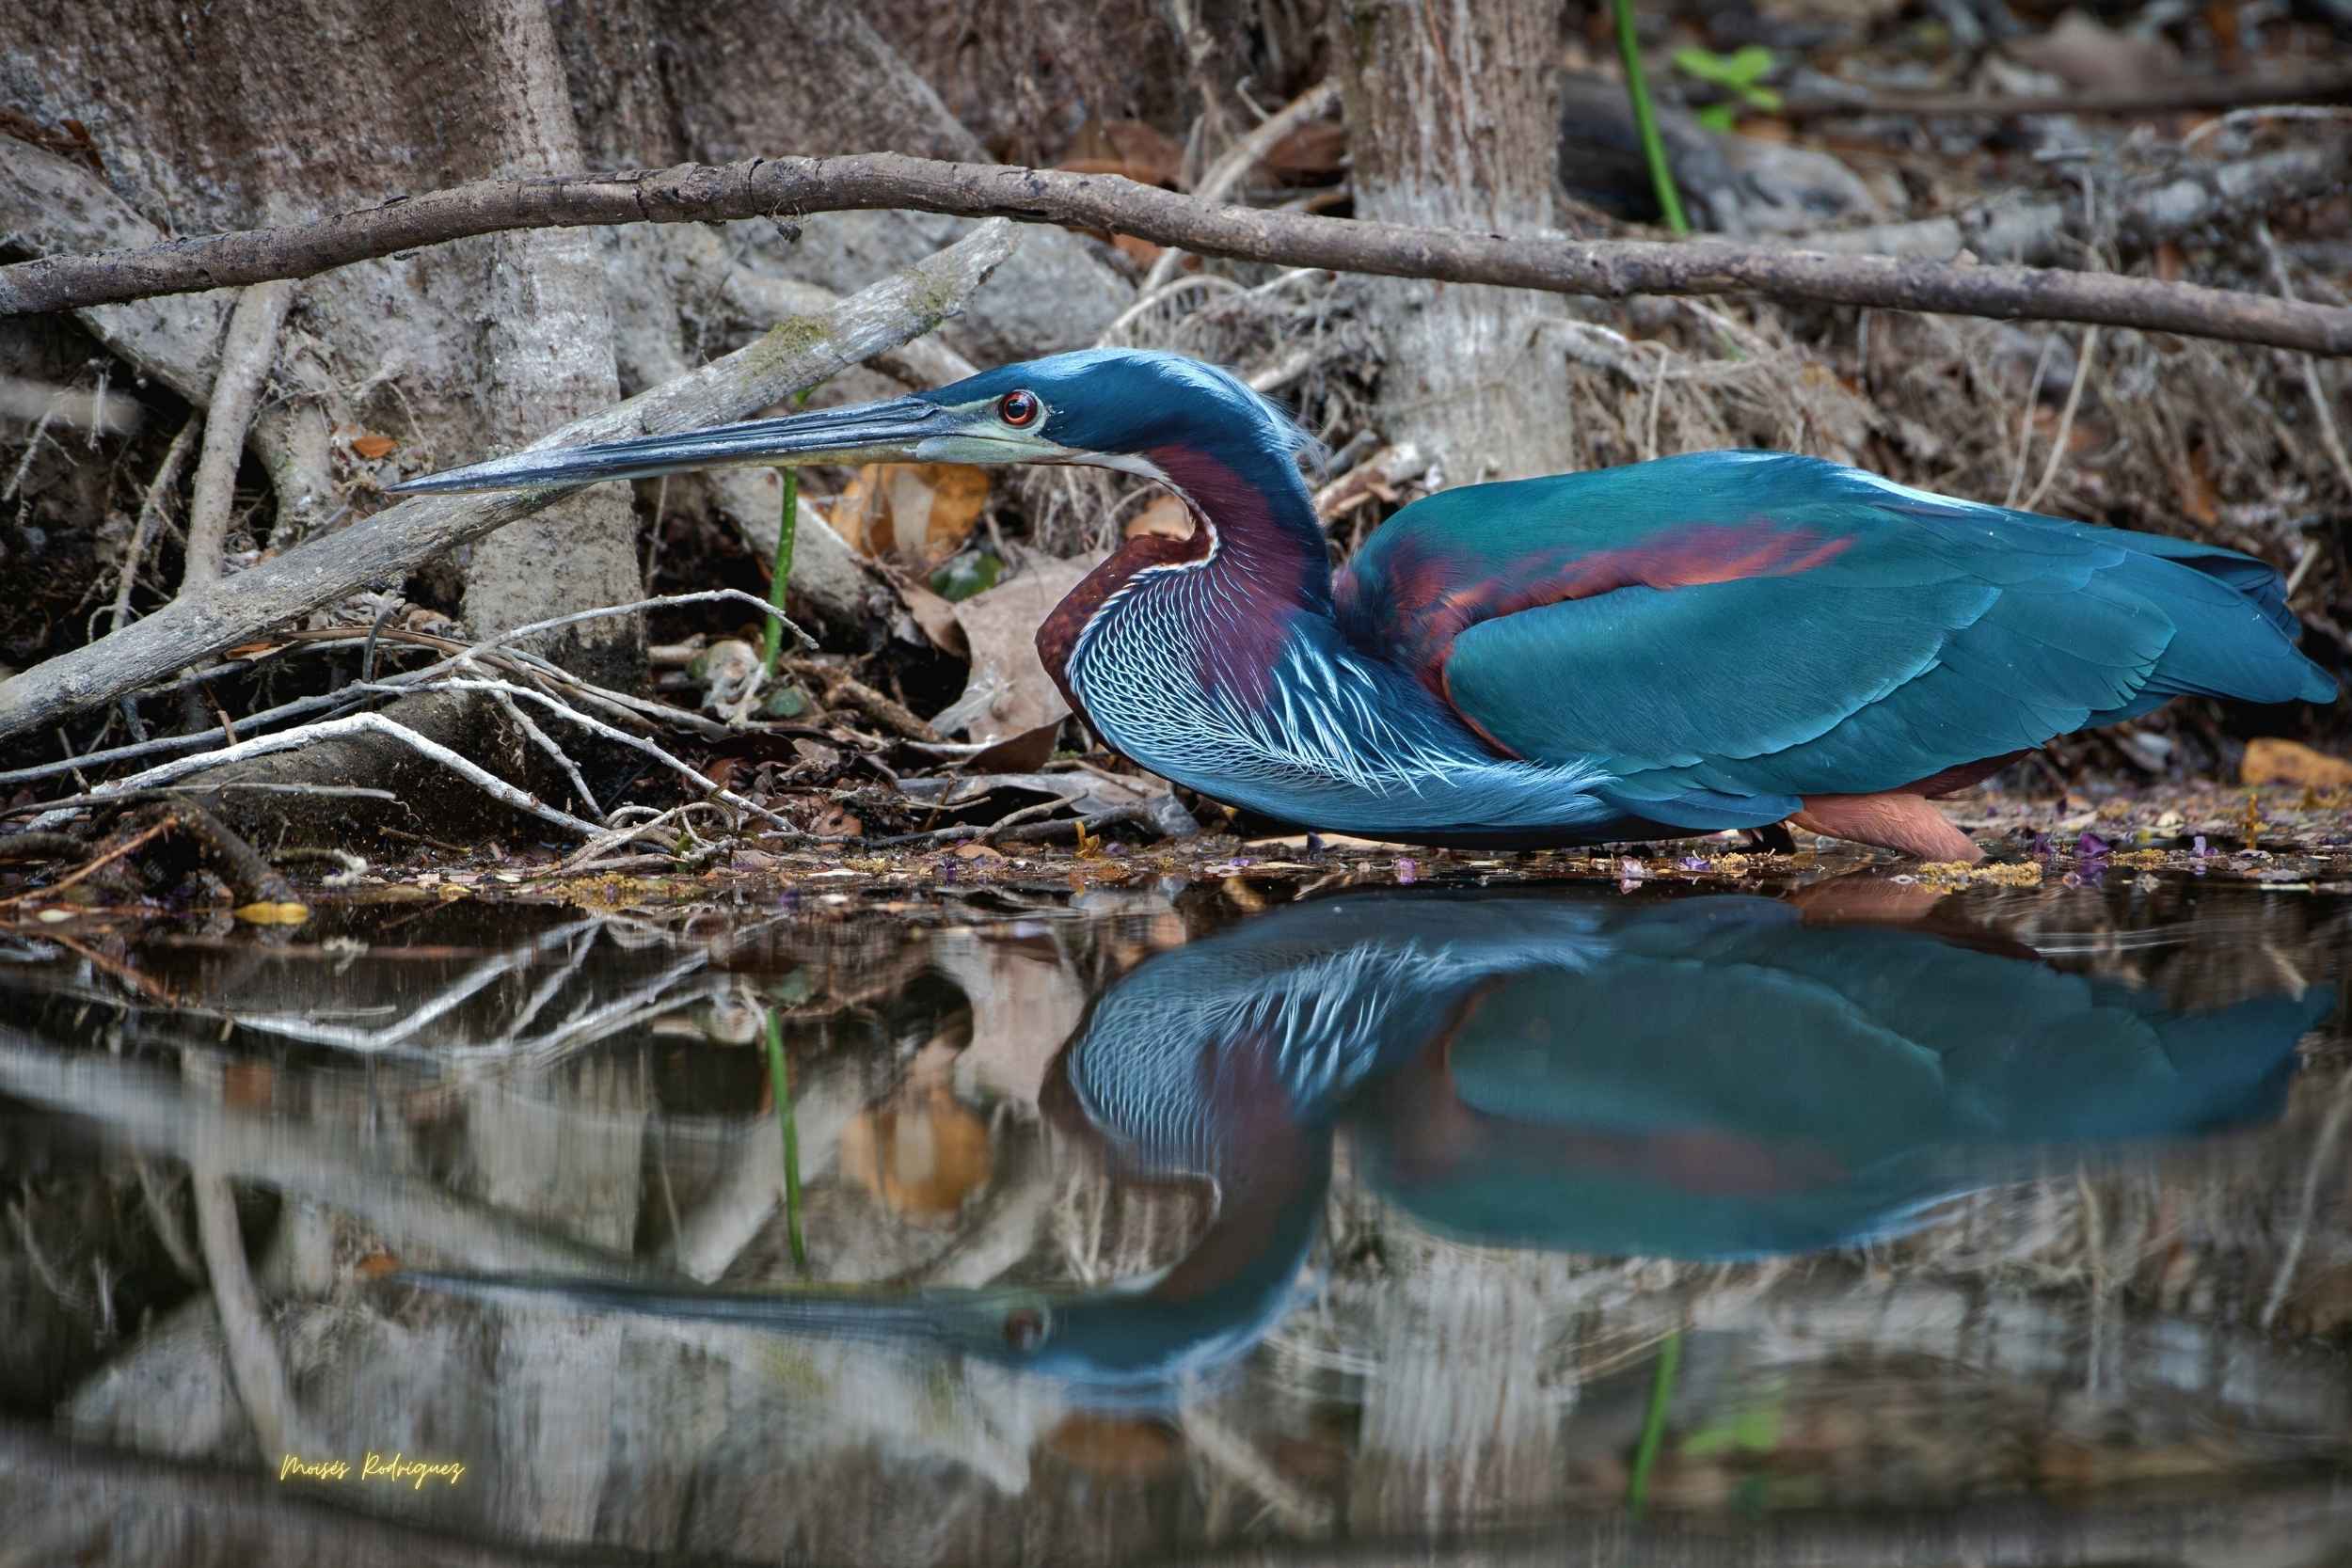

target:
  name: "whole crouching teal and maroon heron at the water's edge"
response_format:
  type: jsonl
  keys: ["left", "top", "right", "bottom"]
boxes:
{"left": 395, "top": 350, "right": 2336, "bottom": 861}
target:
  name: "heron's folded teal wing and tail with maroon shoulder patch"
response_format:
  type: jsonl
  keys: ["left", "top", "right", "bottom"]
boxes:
{"left": 1339, "top": 451, "right": 2336, "bottom": 828}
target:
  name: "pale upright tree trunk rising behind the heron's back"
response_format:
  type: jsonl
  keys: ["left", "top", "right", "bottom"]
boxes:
{"left": 1331, "top": 0, "right": 1574, "bottom": 484}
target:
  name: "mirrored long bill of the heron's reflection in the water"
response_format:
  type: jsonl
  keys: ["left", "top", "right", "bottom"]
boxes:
{"left": 395, "top": 1270, "right": 1042, "bottom": 1347}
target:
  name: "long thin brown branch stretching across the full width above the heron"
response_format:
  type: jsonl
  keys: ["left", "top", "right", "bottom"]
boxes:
{"left": 0, "top": 152, "right": 2352, "bottom": 355}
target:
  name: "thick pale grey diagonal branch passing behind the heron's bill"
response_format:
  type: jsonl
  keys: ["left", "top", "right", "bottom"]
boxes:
{"left": 0, "top": 215, "right": 1016, "bottom": 747}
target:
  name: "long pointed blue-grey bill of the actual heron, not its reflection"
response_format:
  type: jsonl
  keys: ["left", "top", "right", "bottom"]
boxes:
{"left": 390, "top": 397, "right": 967, "bottom": 494}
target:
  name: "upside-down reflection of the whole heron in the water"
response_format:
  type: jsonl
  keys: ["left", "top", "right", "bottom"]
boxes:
{"left": 405, "top": 891, "right": 2333, "bottom": 1399}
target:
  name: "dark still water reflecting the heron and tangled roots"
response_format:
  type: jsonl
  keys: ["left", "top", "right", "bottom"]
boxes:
{"left": 0, "top": 875, "right": 2352, "bottom": 1563}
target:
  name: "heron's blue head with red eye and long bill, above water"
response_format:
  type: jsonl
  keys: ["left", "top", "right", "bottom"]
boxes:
{"left": 393, "top": 348, "right": 1308, "bottom": 491}
